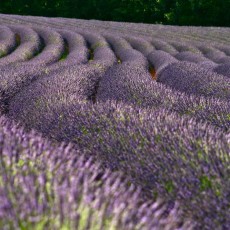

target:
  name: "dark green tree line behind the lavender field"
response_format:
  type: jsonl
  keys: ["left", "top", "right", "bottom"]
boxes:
{"left": 0, "top": 0, "right": 230, "bottom": 26}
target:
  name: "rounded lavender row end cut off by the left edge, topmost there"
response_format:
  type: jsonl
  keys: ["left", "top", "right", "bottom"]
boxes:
{"left": 0, "top": 26, "right": 17, "bottom": 58}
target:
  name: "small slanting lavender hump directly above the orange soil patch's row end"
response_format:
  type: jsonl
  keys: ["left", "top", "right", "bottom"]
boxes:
{"left": 125, "top": 36, "right": 155, "bottom": 56}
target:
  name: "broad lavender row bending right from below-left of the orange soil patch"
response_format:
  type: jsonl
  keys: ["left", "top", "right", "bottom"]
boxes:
{"left": 97, "top": 63, "right": 230, "bottom": 130}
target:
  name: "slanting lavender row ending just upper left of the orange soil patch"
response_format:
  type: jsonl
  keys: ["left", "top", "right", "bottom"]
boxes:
{"left": 106, "top": 35, "right": 148, "bottom": 67}
